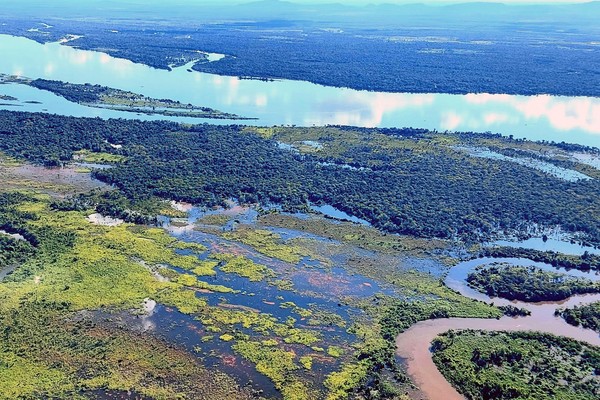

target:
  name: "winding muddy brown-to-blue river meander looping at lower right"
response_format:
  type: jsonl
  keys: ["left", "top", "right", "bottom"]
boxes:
{"left": 396, "top": 258, "right": 600, "bottom": 400}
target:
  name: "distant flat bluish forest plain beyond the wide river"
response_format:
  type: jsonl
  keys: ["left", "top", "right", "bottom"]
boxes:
{"left": 0, "top": 14, "right": 600, "bottom": 96}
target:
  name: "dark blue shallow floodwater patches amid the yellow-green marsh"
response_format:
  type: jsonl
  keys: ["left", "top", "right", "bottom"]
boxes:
{"left": 145, "top": 205, "right": 396, "bottom": 399}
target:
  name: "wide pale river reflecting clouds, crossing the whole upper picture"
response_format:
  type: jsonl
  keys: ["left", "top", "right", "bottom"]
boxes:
{"left": 0, "top": 35, "right": 600, "bottom": 146}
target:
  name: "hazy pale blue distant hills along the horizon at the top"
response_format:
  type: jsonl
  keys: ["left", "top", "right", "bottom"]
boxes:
{"left": 0, "top": 0, "right": 600, "bottom": 26}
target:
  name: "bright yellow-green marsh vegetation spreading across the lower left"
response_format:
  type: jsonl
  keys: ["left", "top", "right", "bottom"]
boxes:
{"left": 0, "top": 186, "right": 370, "bottom": 399}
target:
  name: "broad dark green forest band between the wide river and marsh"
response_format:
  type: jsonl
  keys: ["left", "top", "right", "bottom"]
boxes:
{"left": 0, "top": 112, "right": 600, "bottom": 243}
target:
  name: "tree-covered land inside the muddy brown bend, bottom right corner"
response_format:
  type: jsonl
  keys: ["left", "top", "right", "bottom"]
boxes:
{"left": 432, "top": 330, "right": 600, "bottom": 400}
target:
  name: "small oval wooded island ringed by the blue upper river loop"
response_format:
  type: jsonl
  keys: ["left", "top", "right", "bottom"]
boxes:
{"left": 467, "top": 263, "right": 600, "bottom": 302}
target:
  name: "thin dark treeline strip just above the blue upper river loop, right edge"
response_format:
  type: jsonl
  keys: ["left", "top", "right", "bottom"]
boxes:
{"left": 482, "top": 246, "right": 600, "bottom": 271}
